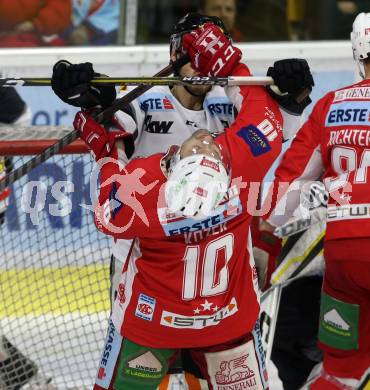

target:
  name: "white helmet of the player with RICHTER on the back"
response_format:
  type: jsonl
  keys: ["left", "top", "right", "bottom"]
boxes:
{"left": 351, "top": 12, "right": 370, "bottom": 78}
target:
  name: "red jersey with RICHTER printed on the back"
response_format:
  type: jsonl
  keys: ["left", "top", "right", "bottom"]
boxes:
{"left": 264, "top": 80, "right": 370, "bottom": 240}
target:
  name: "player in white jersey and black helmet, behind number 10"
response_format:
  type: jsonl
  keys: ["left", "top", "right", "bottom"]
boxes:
{"left": 52, "top": 13, "right": 313, "bottom": 389}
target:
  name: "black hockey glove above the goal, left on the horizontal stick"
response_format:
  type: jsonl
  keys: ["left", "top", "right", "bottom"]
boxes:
{"left": 51, "top": 60, "right": 116, "bottom": 108}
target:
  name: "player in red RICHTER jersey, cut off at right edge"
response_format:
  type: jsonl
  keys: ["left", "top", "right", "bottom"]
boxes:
{"left": 260, "top": 13, "right": 370, "bottom": 390}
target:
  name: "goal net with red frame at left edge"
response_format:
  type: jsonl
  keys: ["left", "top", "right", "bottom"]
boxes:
{"left": 0, "top": 127, "right": 110, "bottom": 390}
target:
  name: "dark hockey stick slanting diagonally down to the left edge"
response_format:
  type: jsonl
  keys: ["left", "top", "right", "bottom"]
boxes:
{"left": 0, "top": 65, "right": 173, "bottom": 192}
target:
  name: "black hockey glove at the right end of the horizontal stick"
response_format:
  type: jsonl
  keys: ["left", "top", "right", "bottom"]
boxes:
{"left": 267, "top": 58, "right": 315, "bottom": 115}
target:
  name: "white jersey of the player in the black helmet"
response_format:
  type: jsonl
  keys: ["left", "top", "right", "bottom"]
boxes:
{"left": 112, "top": 86, "right": 236, "bottom": 262}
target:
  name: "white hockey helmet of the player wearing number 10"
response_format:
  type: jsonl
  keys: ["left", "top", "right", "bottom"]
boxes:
{"left": 165, "top": 154, "right": 229, "bottom": 219}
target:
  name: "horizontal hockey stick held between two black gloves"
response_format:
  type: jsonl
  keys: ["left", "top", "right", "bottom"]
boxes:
{"left": 0, "top": 75, "right": 274, "bottom": 87}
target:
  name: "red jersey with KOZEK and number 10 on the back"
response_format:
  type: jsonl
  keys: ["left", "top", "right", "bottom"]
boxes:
{"left": 96, "top": 66, "right": 282, "bottom": 348}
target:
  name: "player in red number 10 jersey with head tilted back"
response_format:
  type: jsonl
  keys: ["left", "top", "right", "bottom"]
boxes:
{"left": 74, "top": 23, "right": 283, "bottom": 390}
